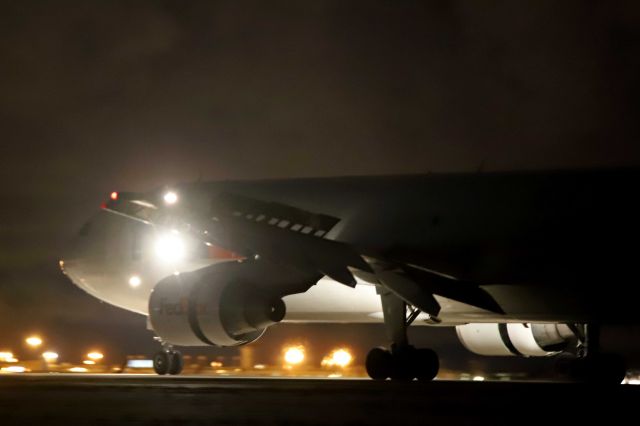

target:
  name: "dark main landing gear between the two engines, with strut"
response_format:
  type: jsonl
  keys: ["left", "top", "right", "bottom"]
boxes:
{"left": 366, "top": 289, "right": 440, "bottom": 381}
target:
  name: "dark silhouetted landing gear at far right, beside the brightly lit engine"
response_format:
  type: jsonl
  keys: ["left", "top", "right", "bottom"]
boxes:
{"left": 557, "top": 324, "right": 627, "bottom": 384}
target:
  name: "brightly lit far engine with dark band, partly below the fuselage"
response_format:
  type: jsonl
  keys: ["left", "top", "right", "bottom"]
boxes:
{"left": 456, "top": 323, "right": 573, "bottom": 357}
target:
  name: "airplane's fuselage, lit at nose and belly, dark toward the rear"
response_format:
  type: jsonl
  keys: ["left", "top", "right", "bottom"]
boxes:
{"left": 63, "top": 171, "right": 640, "bottom": 324}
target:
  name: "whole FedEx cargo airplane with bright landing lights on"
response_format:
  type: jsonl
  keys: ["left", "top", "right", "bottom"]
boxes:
{"left": 60, "top": 168, "right": 640, "bottom": 383}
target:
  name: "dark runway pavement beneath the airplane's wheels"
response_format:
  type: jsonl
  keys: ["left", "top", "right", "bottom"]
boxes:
{"left": 0, "top": 374, "right": 640, "bottom": 426}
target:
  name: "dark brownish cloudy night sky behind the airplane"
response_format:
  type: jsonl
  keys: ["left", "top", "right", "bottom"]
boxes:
{"left": 0, "top": 0, "right": 640, "bottom": 366}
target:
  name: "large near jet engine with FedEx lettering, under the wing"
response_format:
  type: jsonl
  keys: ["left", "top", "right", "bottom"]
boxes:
{"left": 149, "top": 264, "right": 286, "bottom": 346}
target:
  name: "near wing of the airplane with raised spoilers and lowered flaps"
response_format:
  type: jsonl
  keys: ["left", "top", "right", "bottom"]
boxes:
{"left": 103, "top": 192, "right": 504, "bottom": 317}
